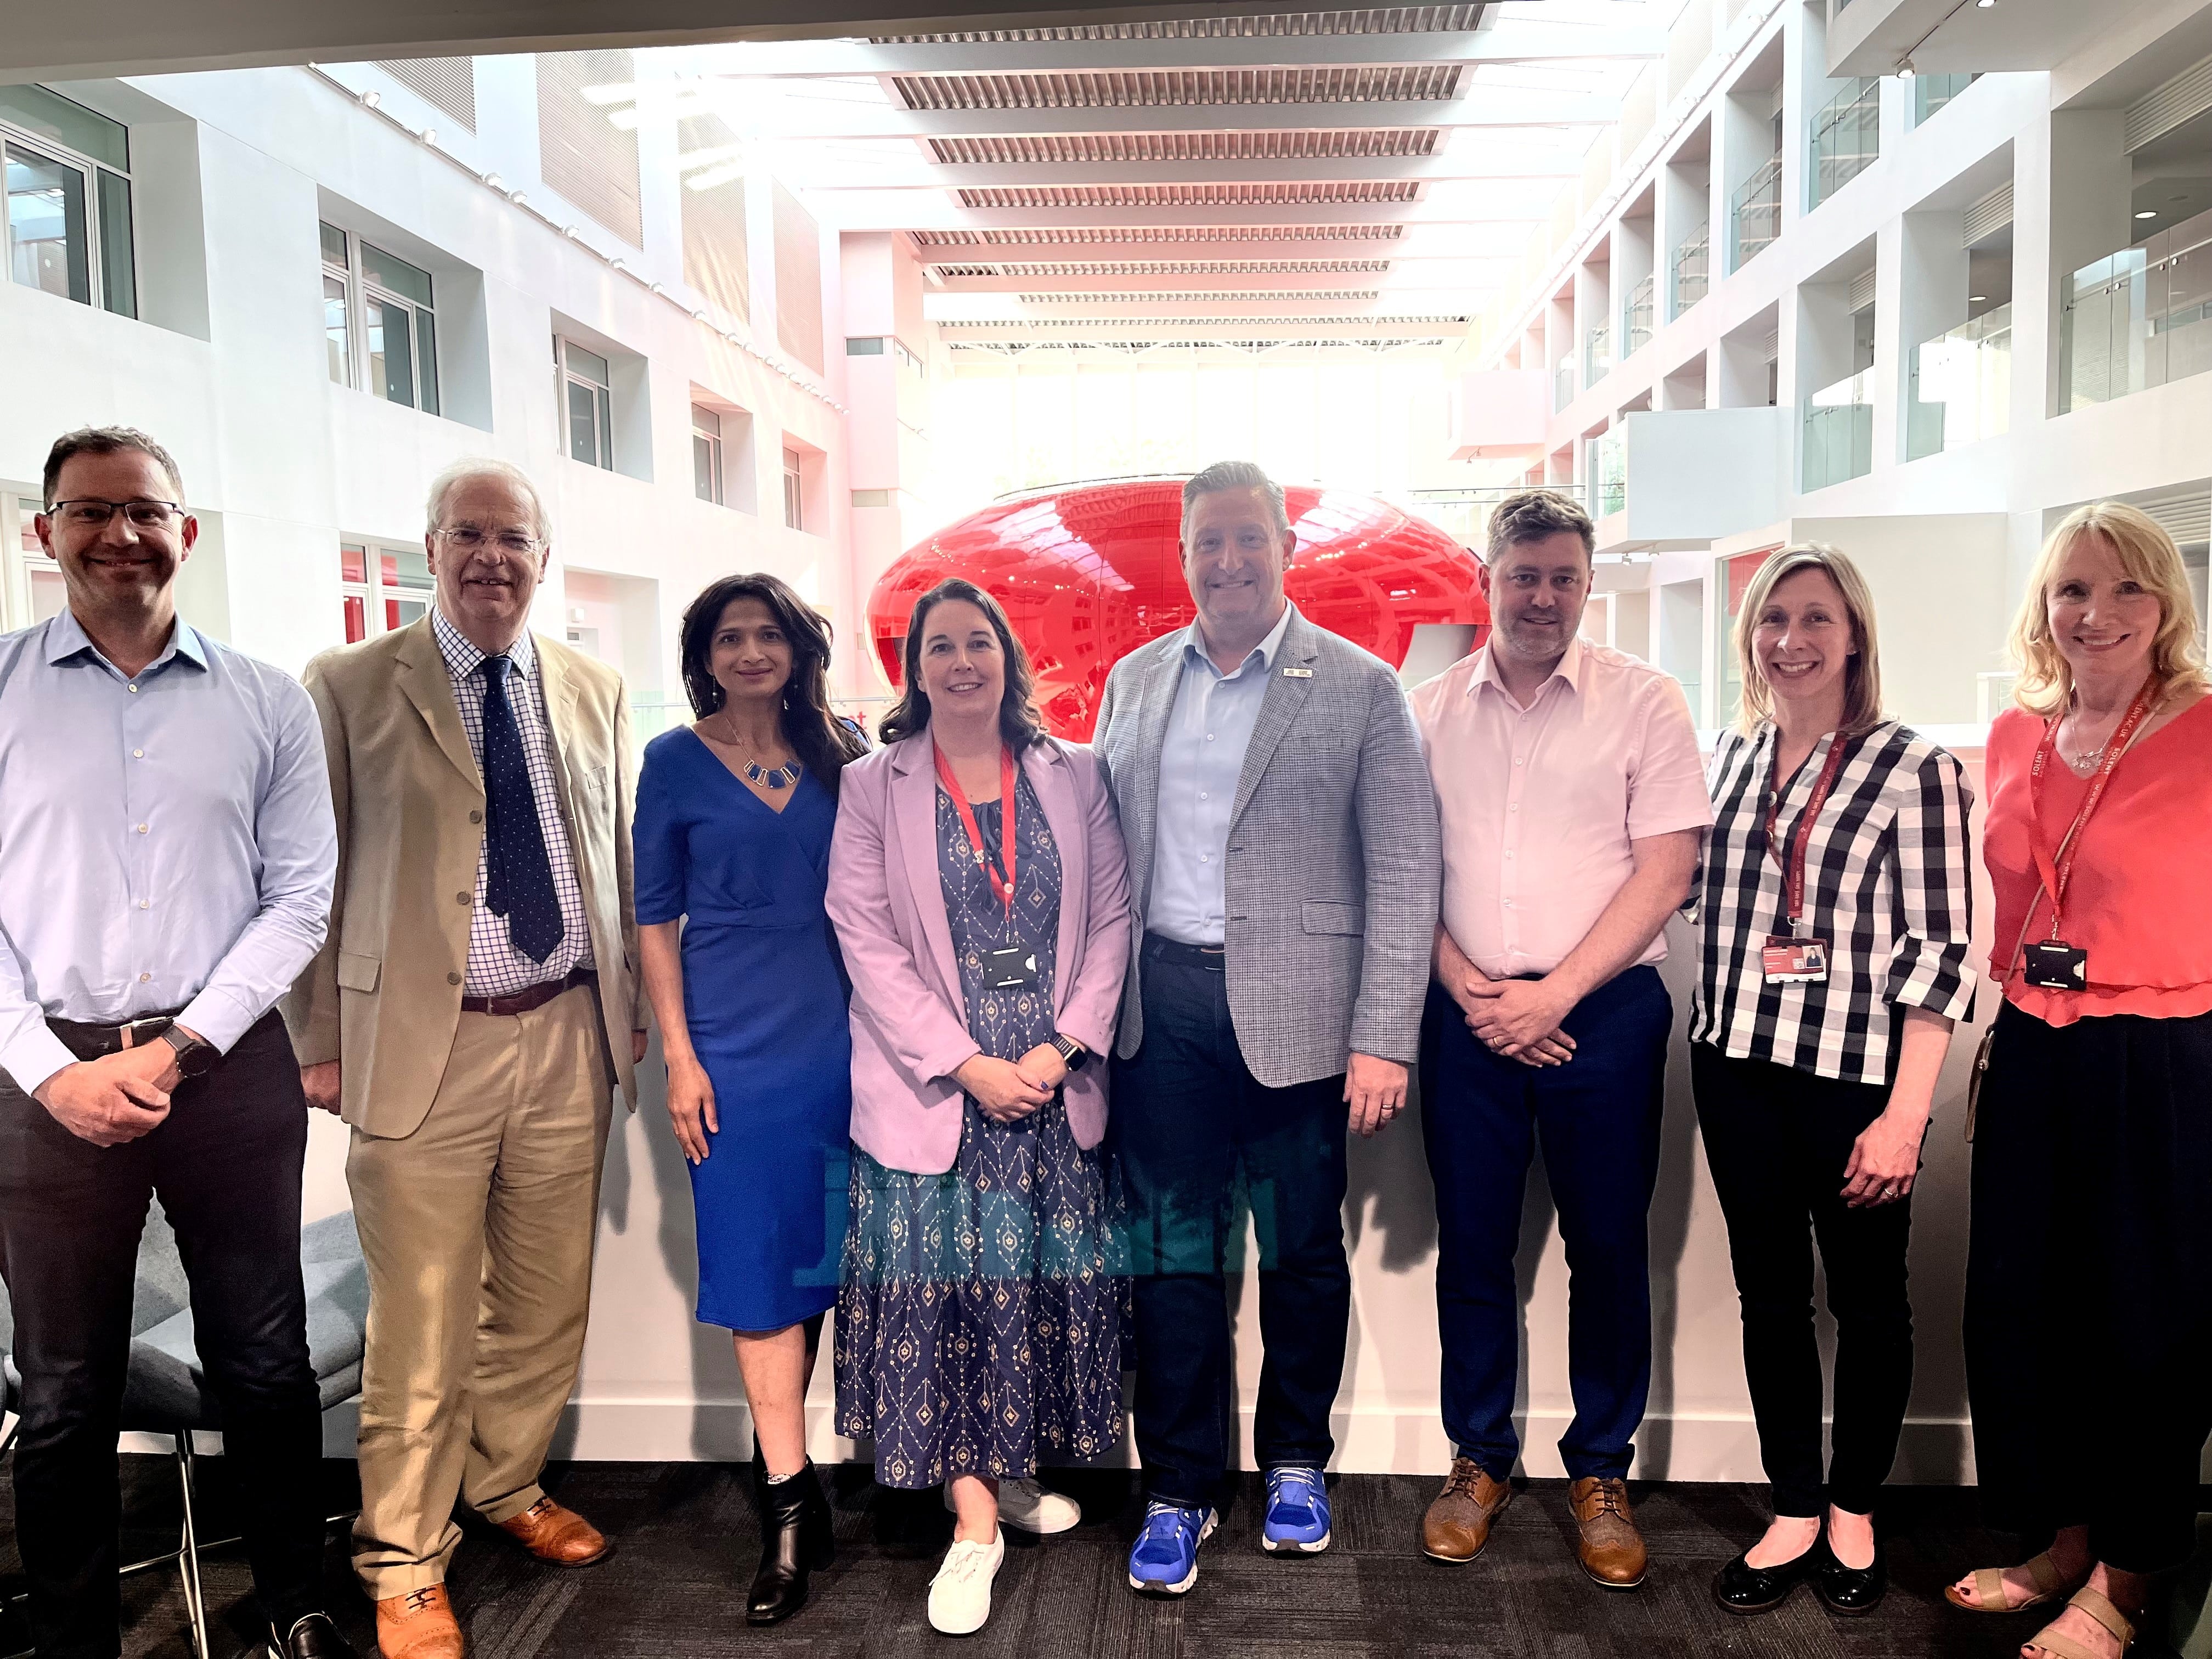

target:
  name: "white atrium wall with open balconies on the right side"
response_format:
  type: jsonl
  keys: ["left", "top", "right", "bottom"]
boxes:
{"left": 1466, "top": 0, "right": 2212, "bottom": 725}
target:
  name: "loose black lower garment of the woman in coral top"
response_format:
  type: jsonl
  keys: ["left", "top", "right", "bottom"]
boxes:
{"left": 1966, "top": 1002, "right": 2212, "bottom": 1573}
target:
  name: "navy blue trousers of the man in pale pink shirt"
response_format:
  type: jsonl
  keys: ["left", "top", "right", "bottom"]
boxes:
{"left": 1420, "top": 967, "right": 1674, "bottom": 1480}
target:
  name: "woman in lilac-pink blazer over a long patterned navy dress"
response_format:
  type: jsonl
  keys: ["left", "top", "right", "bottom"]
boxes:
{"left": 827, "top": 579, "right": 1130, "bottom": 1635}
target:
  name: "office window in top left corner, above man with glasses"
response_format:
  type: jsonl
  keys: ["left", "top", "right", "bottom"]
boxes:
{"left": 0, "top": 86, "right": 137, "bottom": 317}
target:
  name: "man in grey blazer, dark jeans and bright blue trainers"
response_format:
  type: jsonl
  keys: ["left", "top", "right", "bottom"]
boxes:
{"left": 1095, "top": 462, "right": 1442, "bottom": 1595}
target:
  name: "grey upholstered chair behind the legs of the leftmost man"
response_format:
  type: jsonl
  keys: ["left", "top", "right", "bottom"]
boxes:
{"left": 0, "top": 1205, "right": 369, "bottom": 1659}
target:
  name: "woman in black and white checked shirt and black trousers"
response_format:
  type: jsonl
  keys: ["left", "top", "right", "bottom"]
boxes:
{"left": 1690, "top": 544, "right": 1976, "bottom": 1612}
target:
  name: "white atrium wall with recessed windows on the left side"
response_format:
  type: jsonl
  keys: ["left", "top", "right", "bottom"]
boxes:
{"left": 0, "top": 53, "right": 854, "bottom": 719}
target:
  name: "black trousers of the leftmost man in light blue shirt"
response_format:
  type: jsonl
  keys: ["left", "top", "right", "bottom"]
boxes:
{"left": 0, "top": 1015, "right": 323, "bottom": 1659}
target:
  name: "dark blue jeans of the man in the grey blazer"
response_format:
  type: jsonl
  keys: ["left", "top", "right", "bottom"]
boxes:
{"left": 1108, "top": 938, "right": 1352, "bottom": 1504}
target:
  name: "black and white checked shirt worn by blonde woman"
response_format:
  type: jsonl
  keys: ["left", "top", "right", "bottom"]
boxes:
{"left": 1685, "top": 721, "right": 1976, "bottom": 1084}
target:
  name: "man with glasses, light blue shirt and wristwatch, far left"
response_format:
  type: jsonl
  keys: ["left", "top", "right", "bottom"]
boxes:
{"left": 0, "top": 427, "right": 352, "bottom": 1659}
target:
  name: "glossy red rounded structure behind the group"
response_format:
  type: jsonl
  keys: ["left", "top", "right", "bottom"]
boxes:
{"left": 867, "top": 478, "right": 1491, "bottom": 741}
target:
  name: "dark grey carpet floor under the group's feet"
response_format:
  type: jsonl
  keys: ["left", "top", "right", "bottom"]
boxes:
{"left": 0, "top": 1458, "right": 2163, "bottom": 1659}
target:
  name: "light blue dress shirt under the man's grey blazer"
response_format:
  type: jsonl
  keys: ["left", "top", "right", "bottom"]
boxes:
{"left": 1144, "top": 604, "right": 1292, "bottom": 945}
